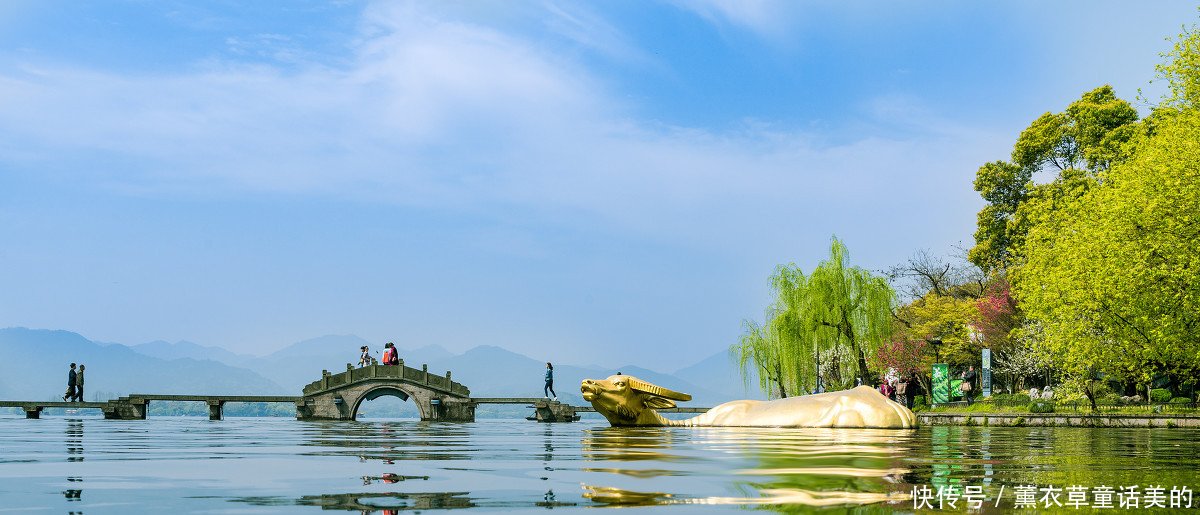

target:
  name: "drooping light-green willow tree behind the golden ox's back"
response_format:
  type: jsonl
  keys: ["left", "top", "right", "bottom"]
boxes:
{"left": 731, "top": 238, "right": 895, "bottom": 391}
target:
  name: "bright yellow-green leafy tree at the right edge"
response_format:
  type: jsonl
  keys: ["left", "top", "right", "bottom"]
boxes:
{"left": 1013, "top": 25, "right": 1200, "bottom": 407}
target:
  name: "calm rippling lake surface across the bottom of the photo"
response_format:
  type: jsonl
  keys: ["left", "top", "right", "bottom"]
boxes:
{"left": 0, "top": 415, "right": 1200, "bottom": 514}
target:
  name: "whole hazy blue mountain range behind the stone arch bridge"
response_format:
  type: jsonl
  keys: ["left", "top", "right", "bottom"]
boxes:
{"left": 7, "top": 328, "right": 763, "bottom": 413}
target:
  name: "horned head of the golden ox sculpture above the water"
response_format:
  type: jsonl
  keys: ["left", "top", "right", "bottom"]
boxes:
{"left": 580, "top": 375, "right": 691, "bottom": 426}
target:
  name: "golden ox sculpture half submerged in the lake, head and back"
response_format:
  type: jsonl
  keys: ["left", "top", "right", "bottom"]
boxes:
{"left": 580, "top": 375, "right": 917, "bottom": 429}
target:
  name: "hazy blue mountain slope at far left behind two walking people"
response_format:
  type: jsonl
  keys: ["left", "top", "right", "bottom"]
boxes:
{"left": 0, "top": 328, "right": 284, "bottom": 400}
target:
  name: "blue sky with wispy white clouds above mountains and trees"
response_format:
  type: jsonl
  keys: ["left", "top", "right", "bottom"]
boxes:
{"left": 0, "top": 0, "right": 1198, "bottom": 370}
